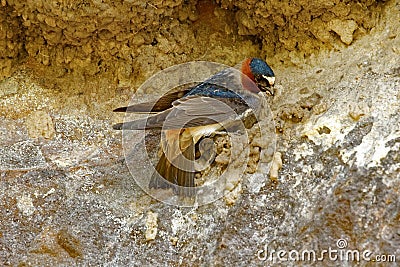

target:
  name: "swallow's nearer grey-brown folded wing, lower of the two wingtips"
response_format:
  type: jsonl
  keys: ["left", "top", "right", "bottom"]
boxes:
{"left": 114, "top": 96, "right": 248, "bottom": 130}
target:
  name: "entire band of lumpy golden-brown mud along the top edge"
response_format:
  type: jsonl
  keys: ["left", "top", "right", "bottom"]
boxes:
{"left": 0, "top": 0, "right": 384, "bottom": 81}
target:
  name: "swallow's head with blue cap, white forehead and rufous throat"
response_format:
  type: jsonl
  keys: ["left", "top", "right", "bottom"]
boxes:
{"left": 242, "top": 58, "right": 275, "bottom": 95}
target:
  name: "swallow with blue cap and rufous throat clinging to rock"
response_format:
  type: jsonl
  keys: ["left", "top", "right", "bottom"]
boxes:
{"left": 113, "top": 57, "right": 275, "bottom": 197}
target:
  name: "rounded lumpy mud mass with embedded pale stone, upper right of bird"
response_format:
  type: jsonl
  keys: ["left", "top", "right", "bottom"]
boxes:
{"left": 218, "top": 0, "right": 380, "bottom": 54}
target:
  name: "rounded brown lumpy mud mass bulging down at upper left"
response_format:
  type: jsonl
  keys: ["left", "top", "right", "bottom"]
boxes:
{"left": 2, "top": 0, "right": 194, "bottom": 80}
